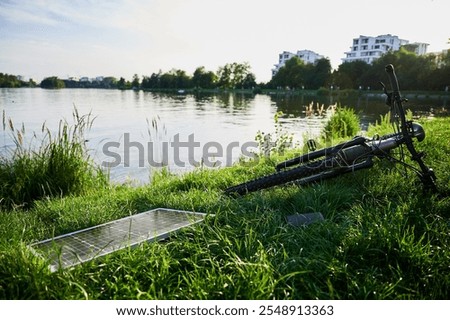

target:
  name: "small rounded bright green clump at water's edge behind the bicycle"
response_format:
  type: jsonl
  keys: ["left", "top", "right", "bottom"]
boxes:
{"left": 323, "top": 107, "right": 360, "bottom": 141}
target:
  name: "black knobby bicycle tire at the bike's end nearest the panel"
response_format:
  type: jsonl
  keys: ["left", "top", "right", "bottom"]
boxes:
{"left": 224, "top": 157, "right": 339, "bottom": 196}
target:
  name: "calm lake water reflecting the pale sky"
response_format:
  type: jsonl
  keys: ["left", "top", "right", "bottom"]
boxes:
{"left": 0, "top": 88, "right": 447, "bottom": 183}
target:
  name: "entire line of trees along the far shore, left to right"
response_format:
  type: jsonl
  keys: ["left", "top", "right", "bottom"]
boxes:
{"left": 0, "top": 48, "right": 450, "bottom": 91}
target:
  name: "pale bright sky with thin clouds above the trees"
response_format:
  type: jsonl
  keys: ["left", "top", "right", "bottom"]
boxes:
{"left": 0, "top": 0, "right": 450, "bottom": 82}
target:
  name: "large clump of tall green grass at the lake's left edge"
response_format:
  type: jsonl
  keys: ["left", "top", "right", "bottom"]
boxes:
{"left": 0, "top": 112, "right": 107, "bottom": 208}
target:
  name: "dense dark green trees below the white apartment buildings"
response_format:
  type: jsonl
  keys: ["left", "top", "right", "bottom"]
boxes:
{"left": 266, "top": 49, "right": 450, "bottom": 91}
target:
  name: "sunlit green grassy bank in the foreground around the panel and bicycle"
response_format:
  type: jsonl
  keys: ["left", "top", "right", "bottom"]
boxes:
{"left": 0, "top": 118, "right": 450, "bottom": 299}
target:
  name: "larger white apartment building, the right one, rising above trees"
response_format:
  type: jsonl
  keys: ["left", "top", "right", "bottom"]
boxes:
{"left": 342, "top": 34, "right": 410, "bottom": 63}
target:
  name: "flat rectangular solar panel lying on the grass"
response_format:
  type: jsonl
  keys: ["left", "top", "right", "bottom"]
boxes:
{"left": 30, "top": 208, "right": 206, "bottom": 271}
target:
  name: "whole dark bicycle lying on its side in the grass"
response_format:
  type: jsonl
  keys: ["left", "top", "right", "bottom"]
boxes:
{"left": 225, "top": 65, "right": 437, "bottom": 195}
